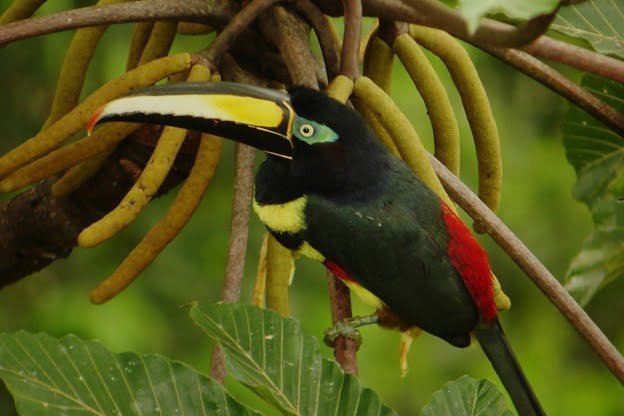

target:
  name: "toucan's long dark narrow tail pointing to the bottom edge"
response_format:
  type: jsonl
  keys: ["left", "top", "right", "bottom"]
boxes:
{"left": 474, "top": 319, "right": 545, "bottom": 416}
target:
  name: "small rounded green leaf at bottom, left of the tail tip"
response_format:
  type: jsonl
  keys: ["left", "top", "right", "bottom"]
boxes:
{"left": 422, "top": 376, "right": 513, "bottom": 416}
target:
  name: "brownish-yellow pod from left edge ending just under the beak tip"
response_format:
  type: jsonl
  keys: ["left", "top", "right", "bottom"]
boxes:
{"left": 0, "top": 123, "right": 140, "bottom": 192}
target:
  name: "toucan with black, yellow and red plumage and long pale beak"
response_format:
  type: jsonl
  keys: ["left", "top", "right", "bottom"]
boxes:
{"left": 88, "top": 82, "right": 544, "bottom": 416}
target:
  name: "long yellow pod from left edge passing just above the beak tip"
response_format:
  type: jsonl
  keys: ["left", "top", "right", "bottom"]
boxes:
{"left": 0, "top": 53, "right": 191, "bottom": 178}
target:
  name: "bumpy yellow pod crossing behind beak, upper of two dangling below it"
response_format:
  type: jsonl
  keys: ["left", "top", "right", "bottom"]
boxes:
{"left": 78, "top": 65, "right": 210, "bottom": 247}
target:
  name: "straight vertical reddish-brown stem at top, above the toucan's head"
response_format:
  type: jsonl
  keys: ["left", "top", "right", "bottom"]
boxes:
{"left": 340, "top": 0, "right": 362, "bottom": 80}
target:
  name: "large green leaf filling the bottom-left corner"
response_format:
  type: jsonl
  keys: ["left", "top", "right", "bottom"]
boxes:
{"left": 0, "top": 331, "right": 256, "bottom": 416}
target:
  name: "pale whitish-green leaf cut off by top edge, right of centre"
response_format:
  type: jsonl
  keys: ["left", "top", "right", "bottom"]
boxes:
{"left": 459, "top": 0, "right": 558, "bottom": 32}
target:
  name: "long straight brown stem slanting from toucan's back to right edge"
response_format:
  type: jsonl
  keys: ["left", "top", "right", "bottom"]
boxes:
{"left": 430, "top": 155, "right": 624, "bottom": 383}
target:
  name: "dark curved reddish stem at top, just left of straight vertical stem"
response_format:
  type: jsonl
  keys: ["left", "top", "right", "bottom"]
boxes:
{"left": 295, "top": 0, "right": 340, "bottom": 80}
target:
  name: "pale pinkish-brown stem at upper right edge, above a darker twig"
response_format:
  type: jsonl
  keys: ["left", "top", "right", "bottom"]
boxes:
{"left": 522, "top": 36, "right": 624, "bottom": 83}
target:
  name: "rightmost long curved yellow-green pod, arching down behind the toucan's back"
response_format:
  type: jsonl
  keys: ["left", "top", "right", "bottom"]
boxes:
{"left": 410, "top": 25, "right": 503, "bottom": 231}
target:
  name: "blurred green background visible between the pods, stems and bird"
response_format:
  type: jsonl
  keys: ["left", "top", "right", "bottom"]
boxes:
{"left": 0, "top": 0, "right": 624, "bottom": 416}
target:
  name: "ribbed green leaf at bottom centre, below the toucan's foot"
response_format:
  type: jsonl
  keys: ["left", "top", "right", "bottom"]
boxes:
{"left": 190, "top": 304, "right": 396, "bottom": 416}
